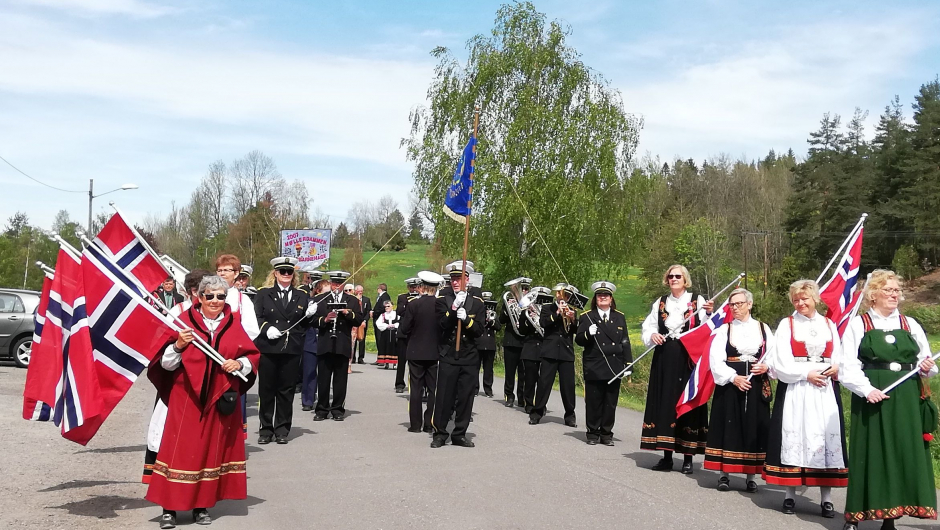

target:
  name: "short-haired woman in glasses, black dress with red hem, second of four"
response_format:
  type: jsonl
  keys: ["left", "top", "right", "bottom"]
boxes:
{"left": 704, "top": 289, "right": 774, "bottom": 493}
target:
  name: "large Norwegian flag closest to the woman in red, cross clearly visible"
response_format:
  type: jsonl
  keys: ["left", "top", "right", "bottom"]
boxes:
{"left": 62, "top": 241, "right": 176, "bottom": 445}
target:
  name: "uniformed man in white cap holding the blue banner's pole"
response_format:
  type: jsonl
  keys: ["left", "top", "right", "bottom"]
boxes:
{"left": 431, "top": 262, "right": 486, "bottom": 448}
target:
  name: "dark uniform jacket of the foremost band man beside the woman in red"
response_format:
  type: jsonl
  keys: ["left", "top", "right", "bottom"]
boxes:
{"left": 254, "top": 285, "right": 313, "bottom": 355}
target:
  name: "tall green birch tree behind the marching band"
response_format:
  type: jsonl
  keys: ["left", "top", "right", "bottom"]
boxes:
{"left": 402, "top": 2, "right": 641, "bottom": 287}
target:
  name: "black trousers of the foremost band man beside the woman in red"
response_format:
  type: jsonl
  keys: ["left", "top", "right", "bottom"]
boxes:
{"left": 258, "top": 353, "right": 300, "bottom": 436}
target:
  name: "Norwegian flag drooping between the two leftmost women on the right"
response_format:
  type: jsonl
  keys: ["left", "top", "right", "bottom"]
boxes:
{"left": 676, "top": 301, "right": 734, "bottom": 417}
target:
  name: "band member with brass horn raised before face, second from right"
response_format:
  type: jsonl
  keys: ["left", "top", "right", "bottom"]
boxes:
{"left": 529, "top": 283, "right": 587, "bottom": 427}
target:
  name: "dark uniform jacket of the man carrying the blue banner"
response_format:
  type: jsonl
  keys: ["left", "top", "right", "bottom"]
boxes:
{"left": 436, "top": 289, "right": 486, "bottom": 365}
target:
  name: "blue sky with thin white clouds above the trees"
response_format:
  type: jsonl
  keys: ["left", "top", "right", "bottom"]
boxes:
{"left": 0, "top": 0, "right": 940, "bottom": 227}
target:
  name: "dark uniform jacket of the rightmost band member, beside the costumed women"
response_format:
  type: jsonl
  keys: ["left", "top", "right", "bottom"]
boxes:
{"left": 574, "top": 309, "right": 633, "bottom": 381}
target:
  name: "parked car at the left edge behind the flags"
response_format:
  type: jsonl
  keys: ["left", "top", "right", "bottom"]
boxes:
{"left": 0, "top": 288, "right": 40, "bottom": 368}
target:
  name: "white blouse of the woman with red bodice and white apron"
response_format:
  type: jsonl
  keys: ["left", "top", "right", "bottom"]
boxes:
{"left": 773, "top": 311, "right": 842, "bottom": 384}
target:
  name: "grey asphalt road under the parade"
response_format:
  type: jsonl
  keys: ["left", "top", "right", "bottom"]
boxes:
{"left": 0, "top": 357, "right": 938, "bottom": 530}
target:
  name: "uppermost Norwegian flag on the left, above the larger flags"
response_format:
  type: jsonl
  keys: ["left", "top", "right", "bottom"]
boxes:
{"left": 95, "top": 212, "right": 171, "bottom": 292}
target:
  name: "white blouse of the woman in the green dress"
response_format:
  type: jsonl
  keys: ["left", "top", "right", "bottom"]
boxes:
{"left": 839, "top": 309, "right": 937, "bottom": 397}
